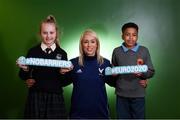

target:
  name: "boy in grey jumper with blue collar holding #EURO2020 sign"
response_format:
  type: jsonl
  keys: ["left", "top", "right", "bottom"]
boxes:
{"left": 112, "top": 23, "right": 154, "bottom": 119}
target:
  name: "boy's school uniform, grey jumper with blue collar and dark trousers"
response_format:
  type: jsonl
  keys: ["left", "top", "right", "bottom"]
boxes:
{"left": 112, "top": 43, "right": 155, "bottom": 119}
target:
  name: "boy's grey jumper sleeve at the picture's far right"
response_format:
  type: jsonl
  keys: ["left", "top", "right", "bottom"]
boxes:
{"left": 139, "top": 49, "right": 155, "bottom": 80}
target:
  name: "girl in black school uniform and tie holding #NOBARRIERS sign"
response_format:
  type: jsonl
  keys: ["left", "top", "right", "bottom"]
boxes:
{"left": 18, "top": 15, "right": 67, "bottom": 118}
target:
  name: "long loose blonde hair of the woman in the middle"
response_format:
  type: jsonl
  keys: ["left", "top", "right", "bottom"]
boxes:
{"left": 78, "top": 29, "right": 104, "bottom": 66}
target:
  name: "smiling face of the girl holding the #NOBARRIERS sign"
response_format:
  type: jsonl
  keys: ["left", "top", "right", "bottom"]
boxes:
{"left": 41, "top": 23, "right": 57, "bottom": 47}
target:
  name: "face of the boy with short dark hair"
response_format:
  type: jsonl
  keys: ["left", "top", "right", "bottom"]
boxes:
{"left": 122, "top": 28, "right": 138, "bottom": 49}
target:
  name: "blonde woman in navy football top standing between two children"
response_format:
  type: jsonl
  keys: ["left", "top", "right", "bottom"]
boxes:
{"left": 62, "top": 29, "right": 113, "bottom": 119}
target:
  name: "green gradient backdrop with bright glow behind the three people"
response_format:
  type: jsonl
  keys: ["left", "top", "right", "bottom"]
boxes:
{"left": 0, "top": 0, "right": 180, "bottom": 118}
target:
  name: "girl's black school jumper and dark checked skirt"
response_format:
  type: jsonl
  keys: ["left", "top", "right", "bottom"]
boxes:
{"left": 19, "top": 44, "right": 67, "bottom": 118}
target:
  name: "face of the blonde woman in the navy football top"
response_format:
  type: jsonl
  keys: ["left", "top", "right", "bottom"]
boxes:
{"left": 82, "top": 35, "right": 97, "bottom": 56}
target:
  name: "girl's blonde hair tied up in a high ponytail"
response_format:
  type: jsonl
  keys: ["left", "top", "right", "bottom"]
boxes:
{"left": 40, "top": 15, "right": 60, "bottom": 46}
